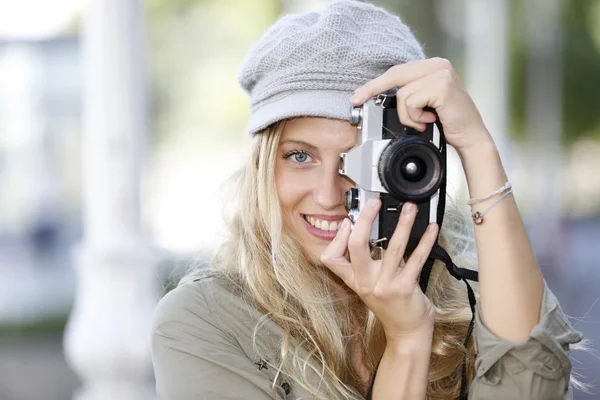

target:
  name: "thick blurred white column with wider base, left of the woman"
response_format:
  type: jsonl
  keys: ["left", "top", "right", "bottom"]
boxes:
{"left": 64, "top": 0, "right": 159, "bottom": 400}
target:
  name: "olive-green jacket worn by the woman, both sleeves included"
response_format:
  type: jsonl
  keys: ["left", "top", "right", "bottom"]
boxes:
{"left": 152, "top": 278, "right": 582, "bottom": 400}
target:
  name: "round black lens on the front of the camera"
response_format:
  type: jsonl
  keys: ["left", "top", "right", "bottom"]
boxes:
{"left": 378, "top": 137, "right": 445, "bottom": 203}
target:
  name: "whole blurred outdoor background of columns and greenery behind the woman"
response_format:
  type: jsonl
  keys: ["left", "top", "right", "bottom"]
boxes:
{"left": 0, "top": 0, "right": 600, "bottom": 400}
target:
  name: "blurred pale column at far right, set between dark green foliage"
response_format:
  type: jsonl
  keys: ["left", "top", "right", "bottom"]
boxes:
{"left": 523, "top": 0, "right": 564, "bottom": 266}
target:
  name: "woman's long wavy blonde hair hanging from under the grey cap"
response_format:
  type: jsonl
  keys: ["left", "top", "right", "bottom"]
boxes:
{"left": 181, "top": 121, "right": 588, "bottom": 400}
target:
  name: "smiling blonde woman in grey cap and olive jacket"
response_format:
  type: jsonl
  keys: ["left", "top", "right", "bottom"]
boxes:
{"left": 152, "top": 0, "right": 582, "bottom": 400}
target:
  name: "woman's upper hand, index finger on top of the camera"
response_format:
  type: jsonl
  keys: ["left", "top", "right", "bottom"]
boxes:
{"left": 350, "top": 58, "right": 492, "bottom": 154}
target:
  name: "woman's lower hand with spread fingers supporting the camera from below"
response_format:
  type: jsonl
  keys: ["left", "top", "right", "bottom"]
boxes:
{"left": 321, "top": 199, "right": 438, "bottom": 343}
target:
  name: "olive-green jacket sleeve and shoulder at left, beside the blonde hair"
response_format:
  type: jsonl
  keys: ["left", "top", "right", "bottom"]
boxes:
{"left": 152, "top": 284, "right": 284, "bottom": 400}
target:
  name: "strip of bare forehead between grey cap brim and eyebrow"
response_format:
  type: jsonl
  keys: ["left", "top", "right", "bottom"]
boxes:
{"left": 280, "top": 117, "right": 358, "bottom": 150}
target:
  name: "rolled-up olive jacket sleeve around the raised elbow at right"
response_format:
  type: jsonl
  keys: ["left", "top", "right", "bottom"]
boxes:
{"left": 469, "top": 286, "right": 583, "bottom": 400}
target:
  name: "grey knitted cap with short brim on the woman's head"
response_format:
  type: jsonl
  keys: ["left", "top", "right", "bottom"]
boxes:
{"left": 238, "top": 0, "right": 424, "bottom": 135}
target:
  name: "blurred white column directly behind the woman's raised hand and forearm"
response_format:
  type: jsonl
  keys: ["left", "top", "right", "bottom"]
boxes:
{"left": 436, "top": 0, "right": 510, "bottom": 203}
